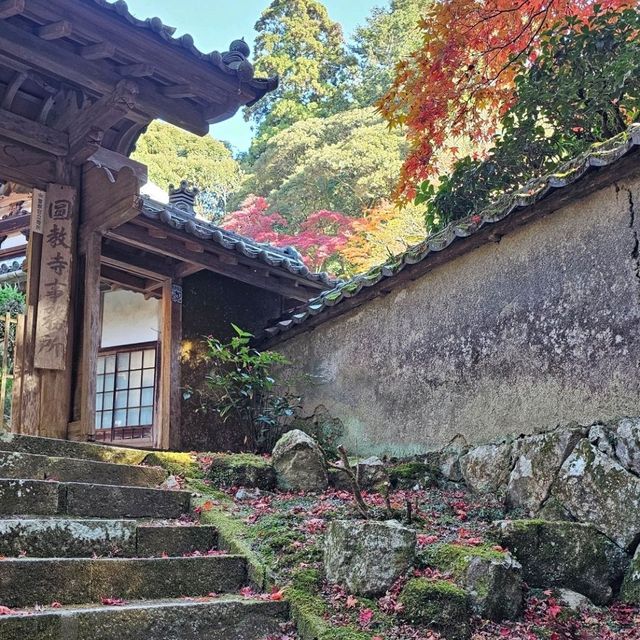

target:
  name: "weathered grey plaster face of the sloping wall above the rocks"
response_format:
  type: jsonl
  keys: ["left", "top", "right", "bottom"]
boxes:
{"left": 276, "top": 172, "right": 640, "bottom": 455}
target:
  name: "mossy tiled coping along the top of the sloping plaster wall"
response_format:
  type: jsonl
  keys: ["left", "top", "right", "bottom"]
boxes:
{"left": 265, "top": 124, "right": 640, "bottom": 338}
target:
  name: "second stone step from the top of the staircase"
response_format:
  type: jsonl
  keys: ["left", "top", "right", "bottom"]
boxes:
{"left": 0, "top": 451, "right": 168, "bottom": 487}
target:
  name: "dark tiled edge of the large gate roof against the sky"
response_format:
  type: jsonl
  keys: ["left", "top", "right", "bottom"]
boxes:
{"left": 86, "top": 0, "right": 278, "bottom": 96}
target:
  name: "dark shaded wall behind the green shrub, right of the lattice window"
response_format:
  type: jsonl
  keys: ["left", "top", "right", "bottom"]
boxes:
{"left": 180, "top": 271, "right": 282, "bottom": 451}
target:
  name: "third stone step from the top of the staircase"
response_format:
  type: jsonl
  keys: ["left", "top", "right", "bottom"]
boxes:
{"left": 0, "top": 478, "right": 191, "bottom": 519}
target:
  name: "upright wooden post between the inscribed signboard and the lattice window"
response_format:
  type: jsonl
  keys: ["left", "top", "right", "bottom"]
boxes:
{"left": 80, "top": 233, "right": 102, "bottom": 440}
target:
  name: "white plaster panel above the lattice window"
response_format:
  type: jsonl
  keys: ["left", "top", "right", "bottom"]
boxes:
{"left": 101, "top": 289, "right": 160, "bottom": 349}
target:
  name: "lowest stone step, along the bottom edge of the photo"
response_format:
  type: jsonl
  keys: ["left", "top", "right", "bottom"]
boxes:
{"left": 0, "top": 598, "right": 288, "bottom": 640}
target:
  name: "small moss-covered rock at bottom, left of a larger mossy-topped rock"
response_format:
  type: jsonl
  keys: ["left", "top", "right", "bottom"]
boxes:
{"left": 400, "top": 578, "right": 471, "bottom": 640}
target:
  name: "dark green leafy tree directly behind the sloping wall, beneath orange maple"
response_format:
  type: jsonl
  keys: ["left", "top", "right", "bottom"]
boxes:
{"left": 416, "top": 9, "right": 640, "bottom": 229}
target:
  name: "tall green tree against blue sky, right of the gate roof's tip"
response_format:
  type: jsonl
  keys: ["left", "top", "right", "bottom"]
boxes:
{"left": 245, "top": 0, "right": 353, "bottom": 155}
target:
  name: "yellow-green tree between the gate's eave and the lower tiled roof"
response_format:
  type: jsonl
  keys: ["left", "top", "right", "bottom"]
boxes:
{"left": 132, "top": 121, "right": 242, "bottom": 219}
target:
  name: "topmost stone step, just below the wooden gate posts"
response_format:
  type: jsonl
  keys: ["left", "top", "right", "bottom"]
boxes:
{"left": 0, "top": 433, "right": 149, "bottom": 464}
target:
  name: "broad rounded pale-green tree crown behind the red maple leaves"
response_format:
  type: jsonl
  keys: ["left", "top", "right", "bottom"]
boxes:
{"left": 231, "top": 108, "right": 406, "bottom": 226}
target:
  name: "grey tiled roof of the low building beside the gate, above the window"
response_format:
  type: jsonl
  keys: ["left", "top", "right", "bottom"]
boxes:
{"left": 140, "top": 196, "right": 341, "bottom": 288}
